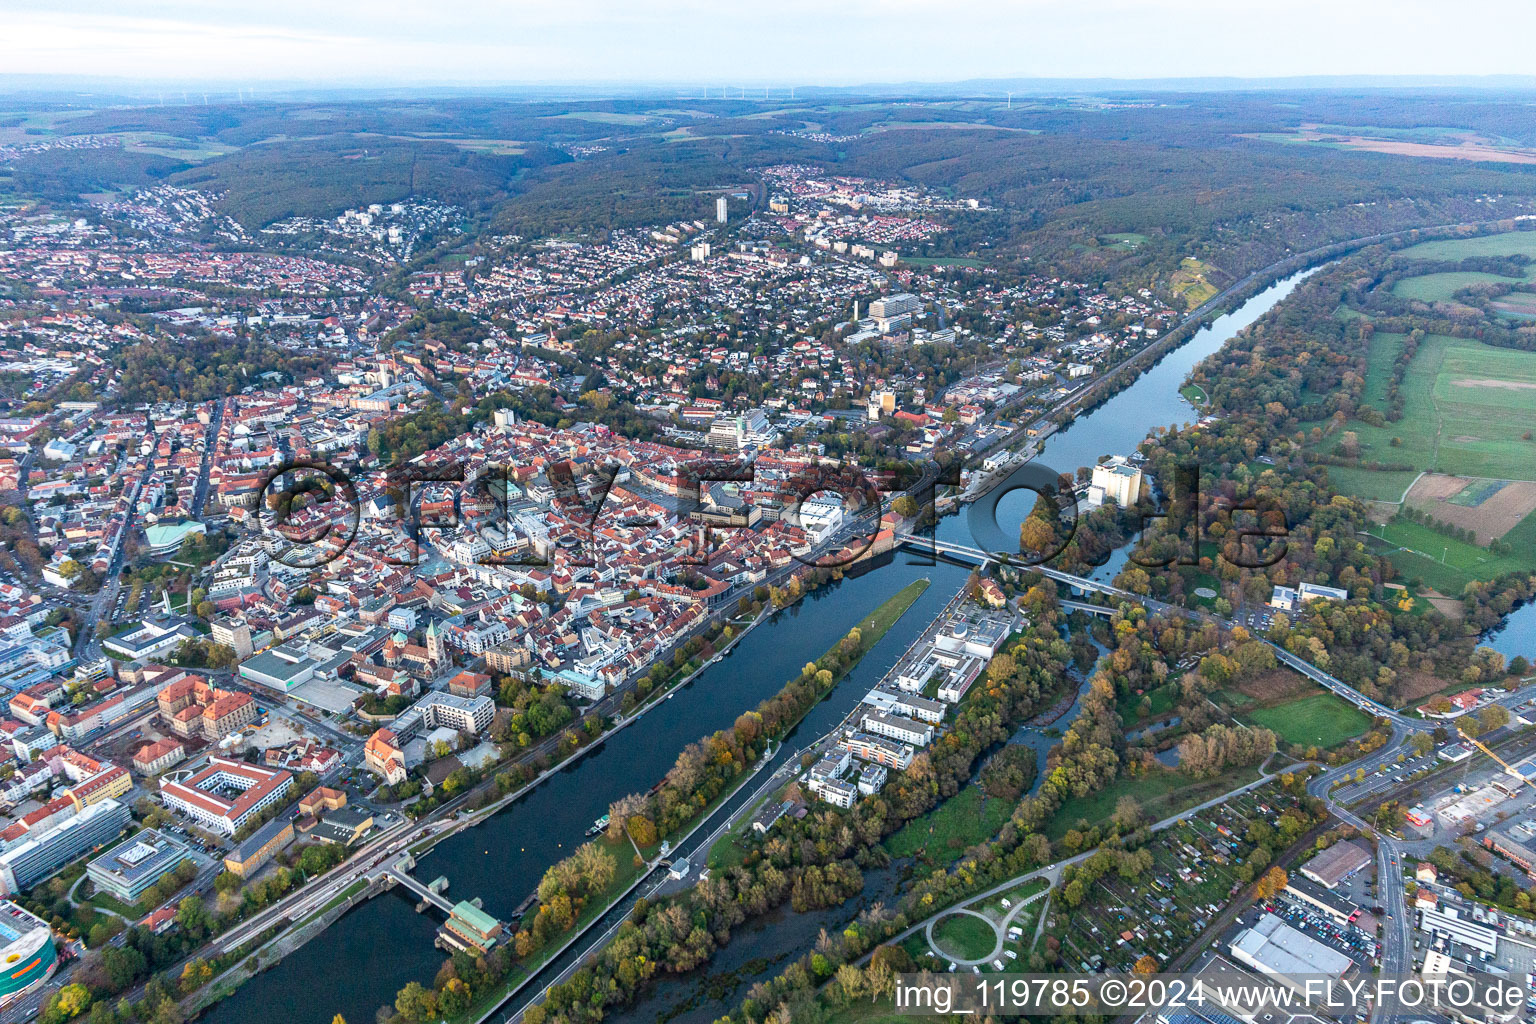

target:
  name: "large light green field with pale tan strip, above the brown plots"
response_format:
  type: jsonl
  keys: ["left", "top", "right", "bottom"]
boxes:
{"left": 1324, "top": 335, "right": 1536, "bottom": 481}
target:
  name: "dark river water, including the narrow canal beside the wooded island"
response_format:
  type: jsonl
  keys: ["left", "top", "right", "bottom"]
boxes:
{"left": 206, "top": 272, "right": 1307, "bottom": 1024}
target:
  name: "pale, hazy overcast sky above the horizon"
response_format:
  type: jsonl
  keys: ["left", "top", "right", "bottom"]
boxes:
{"left": 9, "top": 0, "right": 1536, "bottom": 88}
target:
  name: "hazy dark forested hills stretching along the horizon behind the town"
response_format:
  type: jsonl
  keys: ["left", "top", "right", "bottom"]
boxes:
{"left": 9, "top": 91, "right": 1536, "bottom": 287}
